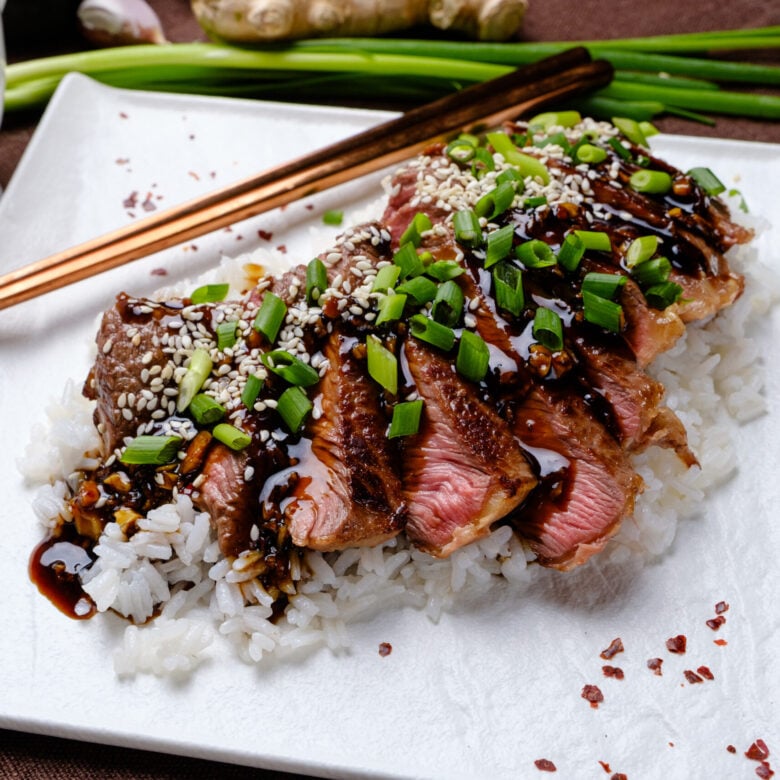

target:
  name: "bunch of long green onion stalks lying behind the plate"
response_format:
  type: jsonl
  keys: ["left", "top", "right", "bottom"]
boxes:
{"left": 5, "top": 26, "right": 780, "bottom": 123}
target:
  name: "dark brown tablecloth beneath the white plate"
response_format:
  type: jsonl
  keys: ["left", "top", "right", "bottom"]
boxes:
{"left": 0, "top": 0, "right": 780, "bottom": 780}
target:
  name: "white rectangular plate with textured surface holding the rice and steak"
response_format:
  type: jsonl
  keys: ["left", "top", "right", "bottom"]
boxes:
{"left": 0, "top": 76, "right": 780, "bottom": 778}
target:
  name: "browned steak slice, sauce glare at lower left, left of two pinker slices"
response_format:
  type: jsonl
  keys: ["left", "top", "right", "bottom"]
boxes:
{"left": 284, "top": 333, "right": 406, "bottom": 550}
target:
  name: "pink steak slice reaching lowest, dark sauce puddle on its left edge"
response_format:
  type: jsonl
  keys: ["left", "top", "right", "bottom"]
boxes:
{"left": 512, "top": 386, "right": 642, "bottom": 571}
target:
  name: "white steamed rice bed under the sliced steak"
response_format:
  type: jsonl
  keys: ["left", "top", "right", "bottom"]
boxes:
{"left": 20, "top": 200, "right": 778, "bottom": 674}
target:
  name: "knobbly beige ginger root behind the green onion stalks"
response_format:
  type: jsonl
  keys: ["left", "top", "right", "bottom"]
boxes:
{"left": 192, "top": 0, "right": 528, "bottom": 43}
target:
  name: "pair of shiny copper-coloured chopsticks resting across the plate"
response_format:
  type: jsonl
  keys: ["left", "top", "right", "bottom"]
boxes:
{"left": 0, "top": 48, "right": 612, "bottom": 309}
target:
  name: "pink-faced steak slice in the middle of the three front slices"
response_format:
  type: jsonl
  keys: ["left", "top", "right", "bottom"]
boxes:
{"left": 403, "top": 338, "right": 536, "bottom": 557}
